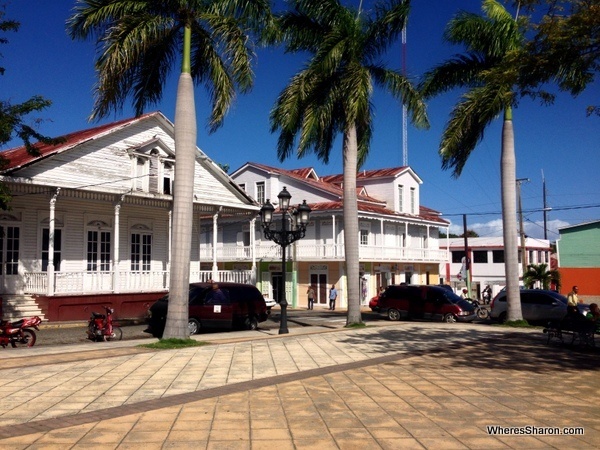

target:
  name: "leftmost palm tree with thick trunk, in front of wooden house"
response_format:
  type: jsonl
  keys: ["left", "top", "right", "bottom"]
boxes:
{"left": 67, "top": 0, "right": 269, "bottom": 338}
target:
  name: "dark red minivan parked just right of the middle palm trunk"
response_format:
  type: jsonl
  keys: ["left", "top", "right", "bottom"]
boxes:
{"left": 377, "top": 285, "right": 476, "bottom": 323}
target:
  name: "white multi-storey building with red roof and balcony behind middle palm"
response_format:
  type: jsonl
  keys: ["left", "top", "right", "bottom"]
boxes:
{"left": 227, "top": 162, "right": 449, "bottom": 307}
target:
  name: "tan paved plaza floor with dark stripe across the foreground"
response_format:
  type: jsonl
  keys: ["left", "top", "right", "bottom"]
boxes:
{"left": 0, "top": 322, "right": 600, "bottom": 450}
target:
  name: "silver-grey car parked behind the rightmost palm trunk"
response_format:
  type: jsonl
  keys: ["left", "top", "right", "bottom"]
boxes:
{"left": 490, "top": 289, "right": 589, "bottom": 323}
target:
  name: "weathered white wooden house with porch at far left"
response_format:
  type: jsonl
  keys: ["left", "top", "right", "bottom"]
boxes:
{"left": 0, "top": 112, "right": 259, "bottom": 320}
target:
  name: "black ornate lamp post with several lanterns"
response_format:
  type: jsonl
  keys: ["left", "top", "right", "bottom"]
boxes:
{"left": 260, "top": 187, "right": 310, "bottom": 334}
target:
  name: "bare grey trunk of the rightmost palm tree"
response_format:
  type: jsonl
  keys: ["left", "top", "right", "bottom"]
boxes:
{"left": 500, "top": 107, "right": 523, "bottom": 321}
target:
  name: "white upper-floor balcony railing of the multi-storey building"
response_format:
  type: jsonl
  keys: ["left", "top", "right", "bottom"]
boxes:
{"left": 200, "top": 241, "right": 448, "bottom": 263}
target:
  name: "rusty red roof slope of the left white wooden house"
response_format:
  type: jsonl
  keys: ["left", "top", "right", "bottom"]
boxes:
{"left": 0, "top": 112, "right": 160, "bottom": 173}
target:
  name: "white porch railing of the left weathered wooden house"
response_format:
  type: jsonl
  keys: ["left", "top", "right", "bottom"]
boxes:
{"left": 24, "top": 270, "right": 255, "bottom": 295}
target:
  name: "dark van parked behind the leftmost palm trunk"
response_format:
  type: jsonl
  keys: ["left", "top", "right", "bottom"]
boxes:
{"left": 144, "top": 283, "right": 268, "bottom": 337}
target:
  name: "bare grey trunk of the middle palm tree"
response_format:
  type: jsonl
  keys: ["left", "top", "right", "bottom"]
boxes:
{"left": 343, "top": 126, "right": 362, "bottom": 325}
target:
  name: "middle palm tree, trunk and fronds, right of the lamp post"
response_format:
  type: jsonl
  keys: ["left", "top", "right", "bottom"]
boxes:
{"left": 271, "top": 0, "right": 428, "bottom": 325}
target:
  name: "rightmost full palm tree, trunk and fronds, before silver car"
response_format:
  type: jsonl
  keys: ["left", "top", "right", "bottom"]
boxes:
{"left": 421, "top": 0, "right": 525, "bottom": 321}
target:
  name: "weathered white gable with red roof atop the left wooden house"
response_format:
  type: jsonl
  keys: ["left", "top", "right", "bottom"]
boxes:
{"left": 1, "top": 112, "right": 258, "bottom": 210}
